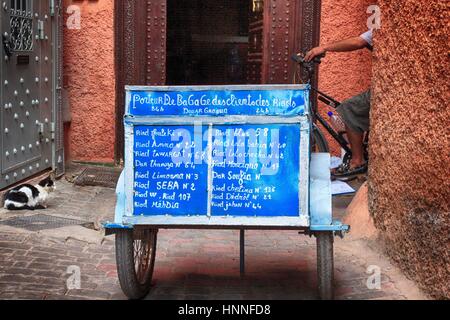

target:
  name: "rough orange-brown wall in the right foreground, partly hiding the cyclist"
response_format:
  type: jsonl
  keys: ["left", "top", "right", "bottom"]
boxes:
{"left": 369, "top": 0, "right": 450, "bottom": 298}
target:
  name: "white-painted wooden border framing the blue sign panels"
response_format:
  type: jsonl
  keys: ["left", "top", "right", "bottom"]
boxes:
{"left": 123, "top": 85, "right": 311, "bottom": 227}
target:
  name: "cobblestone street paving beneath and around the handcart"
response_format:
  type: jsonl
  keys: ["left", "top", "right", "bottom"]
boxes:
{"left": 0, "top": 171, "right": 425, "bottom": 299}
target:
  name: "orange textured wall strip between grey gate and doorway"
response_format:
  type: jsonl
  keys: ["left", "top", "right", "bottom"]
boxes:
{"left": 64, "top": 0, "right": 115, "bottom": 162}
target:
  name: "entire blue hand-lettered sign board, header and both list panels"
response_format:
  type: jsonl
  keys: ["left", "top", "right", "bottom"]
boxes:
{"left": 125, "top": 86, "right": 309, "bottom": 221}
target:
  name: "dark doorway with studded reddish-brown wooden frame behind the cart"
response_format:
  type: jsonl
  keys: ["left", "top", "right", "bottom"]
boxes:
{"left": 114, "top": 0, "right": 321, "bottom": 162}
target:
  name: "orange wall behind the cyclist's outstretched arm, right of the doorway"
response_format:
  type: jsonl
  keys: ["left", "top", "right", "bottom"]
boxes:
{"left": 319, "top": 0, "right": 375, "bottom": 154}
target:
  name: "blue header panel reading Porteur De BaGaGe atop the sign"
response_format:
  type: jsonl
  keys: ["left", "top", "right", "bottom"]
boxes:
{"left": 126, "top": 89, "right": 309, "bottom": 116}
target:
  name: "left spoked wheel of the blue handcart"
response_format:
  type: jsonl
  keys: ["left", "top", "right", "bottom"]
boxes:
{"left": 116, "top": 229, "right": 158, "bottom": 300}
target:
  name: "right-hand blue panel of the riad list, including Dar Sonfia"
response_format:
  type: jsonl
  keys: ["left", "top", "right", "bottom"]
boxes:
{"left": 212, "top": 125, "right": 300, "bottom": 216}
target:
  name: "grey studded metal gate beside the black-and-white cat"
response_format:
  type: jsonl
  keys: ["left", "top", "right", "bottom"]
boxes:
{"left": 0, "top": 0, "right": 64, "bottom": 188}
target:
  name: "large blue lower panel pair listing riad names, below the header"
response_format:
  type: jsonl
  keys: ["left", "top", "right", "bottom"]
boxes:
{"left": 133, "top": 124, "right": 300, "bottom": 216}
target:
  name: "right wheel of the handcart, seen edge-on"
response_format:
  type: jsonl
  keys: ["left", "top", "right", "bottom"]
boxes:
{"left": 316, "top": 231, "right": 334, "bottom": 300}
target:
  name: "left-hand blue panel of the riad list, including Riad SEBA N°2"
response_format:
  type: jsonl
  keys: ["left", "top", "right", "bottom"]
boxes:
{"left": 133, "top": 126, "right": 208, "bottom": 216}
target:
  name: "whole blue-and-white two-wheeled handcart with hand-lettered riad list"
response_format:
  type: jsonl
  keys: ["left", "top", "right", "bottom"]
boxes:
{"left": 104, "top": 85, "right": 349, "bottom": 299}
